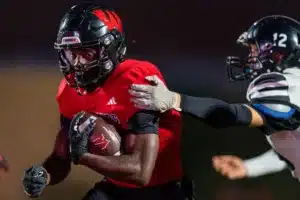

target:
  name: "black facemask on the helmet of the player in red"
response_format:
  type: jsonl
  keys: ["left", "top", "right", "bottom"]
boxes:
{"left": 56, "top": 30, "right": 125, "bottom": 94}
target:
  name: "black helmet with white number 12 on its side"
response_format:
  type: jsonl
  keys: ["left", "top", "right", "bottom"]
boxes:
{"left": 226, "top": 15, "right": 300, "bottom": 81}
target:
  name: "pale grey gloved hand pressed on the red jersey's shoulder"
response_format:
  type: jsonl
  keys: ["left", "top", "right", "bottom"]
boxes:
{"left": 129, "top": 75, "right": 178, "bottom": 112}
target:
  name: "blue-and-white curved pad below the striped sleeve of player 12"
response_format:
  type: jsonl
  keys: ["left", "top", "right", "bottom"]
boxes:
{"left": 252, "top": 104, "right": 296, "bottom": 119}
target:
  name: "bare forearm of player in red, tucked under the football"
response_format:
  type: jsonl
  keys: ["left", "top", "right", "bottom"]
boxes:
{"left": 79, "top": 153, "right": 149, "bottom": 185}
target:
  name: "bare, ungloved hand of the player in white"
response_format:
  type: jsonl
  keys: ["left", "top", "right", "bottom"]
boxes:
{"left": 212, "top": 155, "right": 248, "bottom": 180}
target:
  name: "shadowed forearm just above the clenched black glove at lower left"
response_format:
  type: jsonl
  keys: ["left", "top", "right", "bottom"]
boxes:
{"left": 42, "top": 153, "right": 71, "bottom": 185}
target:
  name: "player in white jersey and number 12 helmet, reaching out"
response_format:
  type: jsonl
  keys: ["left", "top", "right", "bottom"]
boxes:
{"left": 129, "top": 15, "right": 300, "bottom": 178}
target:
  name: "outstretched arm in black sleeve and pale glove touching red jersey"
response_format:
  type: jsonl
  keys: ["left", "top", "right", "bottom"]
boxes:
{"left": 129, "top": 76, "right": 264, "bottom": 128}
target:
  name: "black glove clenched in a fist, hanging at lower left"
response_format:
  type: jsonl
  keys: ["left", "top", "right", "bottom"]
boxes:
{"left": 22, "top": 165, "right": 48, "bottom": 198}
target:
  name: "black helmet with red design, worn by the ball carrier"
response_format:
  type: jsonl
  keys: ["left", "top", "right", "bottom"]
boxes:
{"left": 54, "top": 3, "right": 126, "bottom": 94}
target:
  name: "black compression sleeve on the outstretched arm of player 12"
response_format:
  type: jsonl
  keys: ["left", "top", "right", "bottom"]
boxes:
{"left": 176, "top": 94, "right": 252, "bottom": 128}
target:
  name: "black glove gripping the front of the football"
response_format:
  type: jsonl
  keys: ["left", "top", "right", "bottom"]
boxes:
{"left": 69, "top": 112, "right": 95, "bottom": 164}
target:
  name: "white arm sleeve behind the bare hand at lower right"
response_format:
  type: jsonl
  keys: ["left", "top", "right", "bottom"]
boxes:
{"left": 244, "top": 149, "right": 287, "bottom": 178}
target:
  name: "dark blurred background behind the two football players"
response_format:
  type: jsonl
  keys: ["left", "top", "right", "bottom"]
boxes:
{"left": 0, "top": 0, "right": 300, "bottom": 200}
